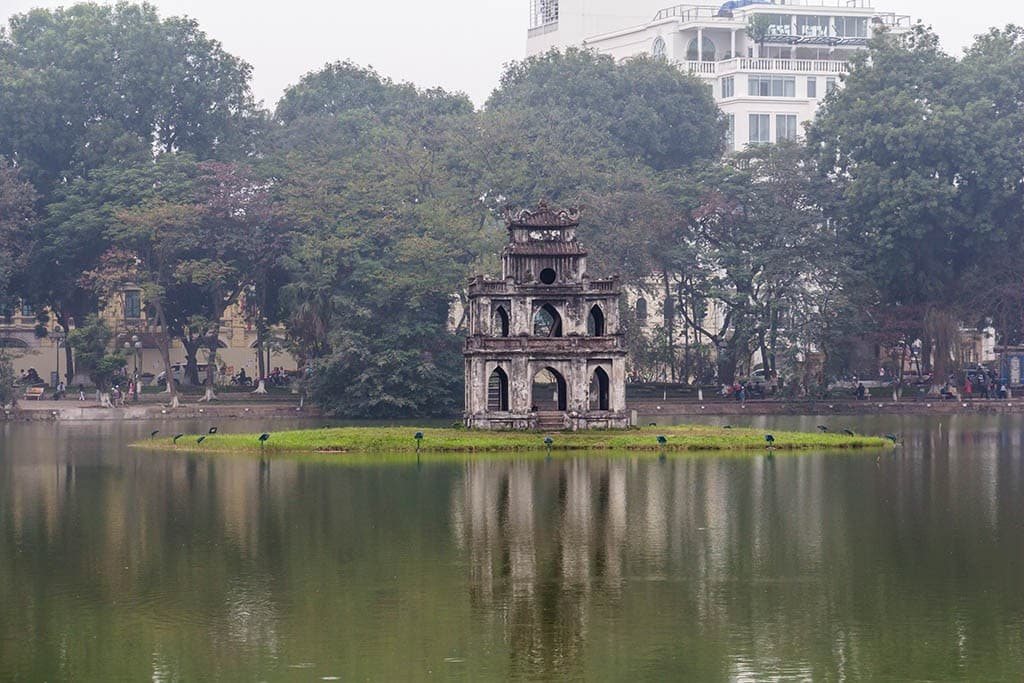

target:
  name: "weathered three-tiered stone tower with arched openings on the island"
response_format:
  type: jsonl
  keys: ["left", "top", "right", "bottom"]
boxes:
{"left": 464, "top": 203, "right": 629, "bottom": 430}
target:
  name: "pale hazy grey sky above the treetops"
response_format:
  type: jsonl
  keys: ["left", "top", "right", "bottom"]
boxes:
{"left": 0, "top": 0, "right": 1024, "bottom": 108}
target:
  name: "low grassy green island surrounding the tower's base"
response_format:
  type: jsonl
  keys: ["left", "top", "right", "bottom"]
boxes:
{"left": 136, "top": 425, "right": 890, "bottom": 455}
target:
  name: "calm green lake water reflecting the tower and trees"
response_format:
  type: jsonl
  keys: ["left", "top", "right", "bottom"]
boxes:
{"left": 0, "top": 416, "right": 1024, "bottom": 681}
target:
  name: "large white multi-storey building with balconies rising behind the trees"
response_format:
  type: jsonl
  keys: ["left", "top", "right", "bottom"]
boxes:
{"left": 526, "top": 0, "right": 910, "bottom": 150}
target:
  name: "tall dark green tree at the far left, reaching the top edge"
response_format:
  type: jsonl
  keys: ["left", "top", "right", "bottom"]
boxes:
{"left": 0, "top": 2, "right": 264, "bottom": 375}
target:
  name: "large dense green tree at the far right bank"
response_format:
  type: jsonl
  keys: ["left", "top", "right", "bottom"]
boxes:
{"left": 808, "top": 27, "right": 1024, "bottom": 383}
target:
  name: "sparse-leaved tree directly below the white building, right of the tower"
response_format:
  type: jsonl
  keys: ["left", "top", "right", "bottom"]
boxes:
{"left": 652, "top": 143, "right": 835, "bottom": 383}
